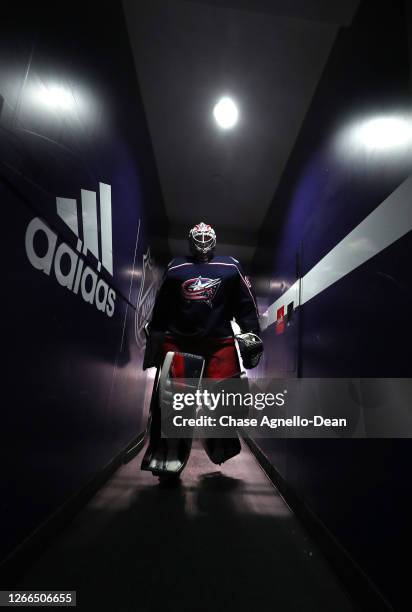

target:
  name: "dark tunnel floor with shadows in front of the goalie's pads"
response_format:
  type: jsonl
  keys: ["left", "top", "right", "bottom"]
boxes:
{"left": 18, "top": 449, "right": 353, "bottom": 612}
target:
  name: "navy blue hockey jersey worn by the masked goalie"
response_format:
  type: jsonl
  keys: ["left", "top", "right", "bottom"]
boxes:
{"left": 150, "top": 257, "right": 259, "bottom": 338}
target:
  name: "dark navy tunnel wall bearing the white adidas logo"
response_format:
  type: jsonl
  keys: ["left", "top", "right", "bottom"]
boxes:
{"left": 0, "top": 2, "right": 167, "bottom": 560}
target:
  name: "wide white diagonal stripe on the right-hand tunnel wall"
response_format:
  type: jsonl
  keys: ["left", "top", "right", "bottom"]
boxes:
{"left": 260, "top": 176, "right": 412, "bottom": 329}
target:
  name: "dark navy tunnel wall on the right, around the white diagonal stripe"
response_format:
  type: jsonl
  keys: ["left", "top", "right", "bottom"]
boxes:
{"left": 254, "top": 2, "right": 412, "bottom": 609}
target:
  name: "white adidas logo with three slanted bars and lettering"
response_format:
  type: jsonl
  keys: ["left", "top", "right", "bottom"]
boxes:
{"left": 25, "top": 183, "right": 116, "bottom": 317}
